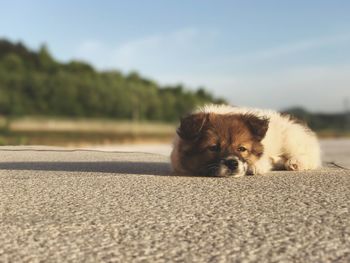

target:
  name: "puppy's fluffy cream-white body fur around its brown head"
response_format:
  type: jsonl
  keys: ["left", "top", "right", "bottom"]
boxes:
{"left": 171, "top": 105, "right": 321, "bottom": 174}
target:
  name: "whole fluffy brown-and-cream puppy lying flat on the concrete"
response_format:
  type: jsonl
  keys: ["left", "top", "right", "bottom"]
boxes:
{"left": 171, "top": 105, "right": 321, "bottom": 176}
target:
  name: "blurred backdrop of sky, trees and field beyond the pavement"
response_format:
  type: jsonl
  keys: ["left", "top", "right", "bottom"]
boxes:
{"left": 0, "top": 0, "right": 350, "bottom": 149}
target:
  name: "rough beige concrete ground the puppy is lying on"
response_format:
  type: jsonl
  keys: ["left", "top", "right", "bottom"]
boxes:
{"left": 0, "top": 140, "right": 350, "bottom": 262}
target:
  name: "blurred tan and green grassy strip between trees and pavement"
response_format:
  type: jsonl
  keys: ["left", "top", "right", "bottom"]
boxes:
{"left": 0, "top": 118, "right": 176, "bottom": 146}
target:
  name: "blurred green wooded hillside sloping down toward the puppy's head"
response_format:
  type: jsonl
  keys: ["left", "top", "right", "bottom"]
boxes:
{"left": 0, "top": 39, "right": 225, "bottom": 121}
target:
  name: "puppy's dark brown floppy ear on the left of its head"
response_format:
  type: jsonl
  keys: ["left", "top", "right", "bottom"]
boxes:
{"left": 176, "top": 112, "right": 209, "bottom": 140}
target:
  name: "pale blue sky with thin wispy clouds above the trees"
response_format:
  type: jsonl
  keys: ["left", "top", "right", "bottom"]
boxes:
{"left": 0, "top": 0, "right": 350, "bottom": 112}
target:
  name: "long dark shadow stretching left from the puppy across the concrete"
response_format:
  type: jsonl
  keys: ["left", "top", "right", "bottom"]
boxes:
{"left": 0, "top": 161, "right": 171, "bottom": 175}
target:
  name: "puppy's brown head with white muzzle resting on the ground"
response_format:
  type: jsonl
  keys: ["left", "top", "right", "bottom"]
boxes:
{"left": 176, "top": 112, "right": 269, "bottom": 176}
